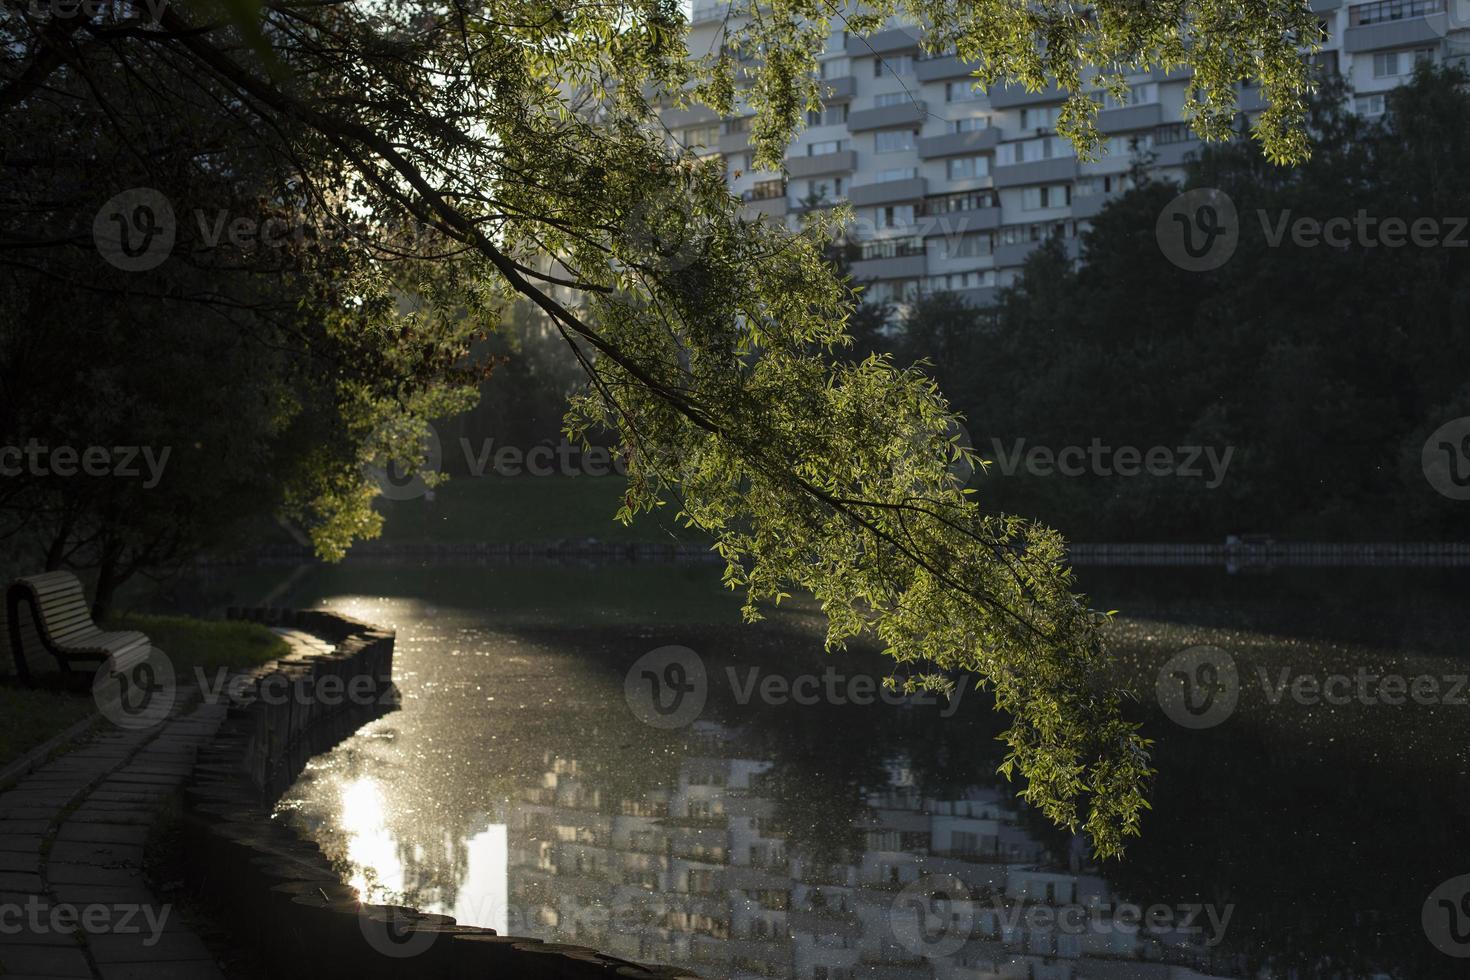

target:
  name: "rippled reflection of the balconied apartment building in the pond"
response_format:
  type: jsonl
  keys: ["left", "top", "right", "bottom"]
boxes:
{"left": 499, "top": 726, "right": 1227, "bottom": 980}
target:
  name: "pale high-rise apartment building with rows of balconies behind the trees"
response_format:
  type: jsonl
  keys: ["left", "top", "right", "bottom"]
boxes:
{"left": 663, "top": 0, "right": 1470, "bottom": 306}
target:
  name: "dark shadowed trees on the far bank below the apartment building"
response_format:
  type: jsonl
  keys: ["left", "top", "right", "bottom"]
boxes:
{"left": 869, "top": 69, "right": 1470, "bottom": 541}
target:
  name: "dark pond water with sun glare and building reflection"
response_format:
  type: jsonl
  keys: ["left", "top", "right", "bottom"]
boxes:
{"left": 198, "top": 563, "right": 1470, "bottom": 980}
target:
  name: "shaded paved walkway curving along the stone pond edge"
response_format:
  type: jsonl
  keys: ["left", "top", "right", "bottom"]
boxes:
{"left": 0, "top": 630, "right": 322, "bottom": 980}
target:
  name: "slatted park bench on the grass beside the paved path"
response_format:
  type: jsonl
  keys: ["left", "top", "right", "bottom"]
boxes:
{"left": 6, "top": 572, "right": 151, "bottom": 683}
